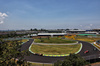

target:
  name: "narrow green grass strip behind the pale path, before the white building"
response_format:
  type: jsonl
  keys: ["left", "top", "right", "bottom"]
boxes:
{"left": 34, "top": 37, "right": 76, "bottom": 44}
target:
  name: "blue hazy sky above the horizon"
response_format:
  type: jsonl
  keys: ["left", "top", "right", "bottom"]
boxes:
{"left": 0, "top": 0, "right": 100, "bottom": 30}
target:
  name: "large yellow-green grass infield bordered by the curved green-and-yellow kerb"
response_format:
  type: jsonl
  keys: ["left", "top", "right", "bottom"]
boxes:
{"left": 31, "top": 44, "right": 81, "bottom": 55}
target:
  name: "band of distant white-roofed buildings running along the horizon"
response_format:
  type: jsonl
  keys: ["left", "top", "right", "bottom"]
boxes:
{"left": 0, "top": 29, "right": 100, "bottom": 36}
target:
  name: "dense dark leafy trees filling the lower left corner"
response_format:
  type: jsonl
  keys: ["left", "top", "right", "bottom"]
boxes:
{"left": 0, "top": 40, "right": 29, "bottom": 66}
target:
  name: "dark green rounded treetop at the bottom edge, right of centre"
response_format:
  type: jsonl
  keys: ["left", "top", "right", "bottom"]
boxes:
{"left": 54, "top": 54, "right": 88, "bottom": 66}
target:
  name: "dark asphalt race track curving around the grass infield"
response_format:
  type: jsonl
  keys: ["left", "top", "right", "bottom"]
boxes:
{"left": 21, "top": 39, "right": 100, "bottom": 63}
